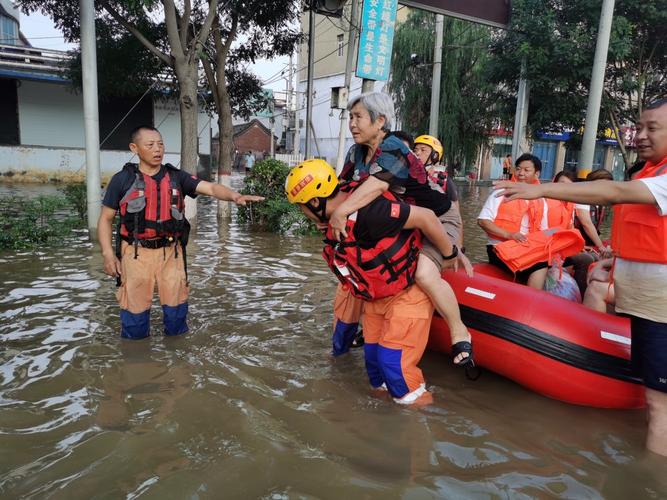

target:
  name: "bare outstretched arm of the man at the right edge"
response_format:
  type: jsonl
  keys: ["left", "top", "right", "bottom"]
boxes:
{"left": 493, "top": 181, "right": 656, "bottom": 205}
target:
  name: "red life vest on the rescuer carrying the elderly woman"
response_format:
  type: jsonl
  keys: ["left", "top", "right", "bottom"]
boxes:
{"left": 322, "top": 183, "right": 422, "bottom": 301}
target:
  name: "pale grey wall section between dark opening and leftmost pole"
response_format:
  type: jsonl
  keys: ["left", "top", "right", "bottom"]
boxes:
{"left": 18, "top": 80, "right": 85, "bottom": 148}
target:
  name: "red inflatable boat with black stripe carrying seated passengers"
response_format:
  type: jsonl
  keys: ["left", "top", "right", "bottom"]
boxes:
{"left": 429, "top": 264, "right": 644, "bottom": 408}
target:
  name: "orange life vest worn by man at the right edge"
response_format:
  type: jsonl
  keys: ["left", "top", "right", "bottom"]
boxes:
{"left": 611, "top": 157, "right": 667, "bottom": 264}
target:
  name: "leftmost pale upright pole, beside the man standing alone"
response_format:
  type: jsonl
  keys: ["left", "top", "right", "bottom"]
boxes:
{"left": 80, "top": 0, "right": 102, "bottom": 239}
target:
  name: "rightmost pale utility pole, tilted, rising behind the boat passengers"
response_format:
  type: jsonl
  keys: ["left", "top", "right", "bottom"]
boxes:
{"left": 577, "top": 0, "right": 614, "bottom": 179}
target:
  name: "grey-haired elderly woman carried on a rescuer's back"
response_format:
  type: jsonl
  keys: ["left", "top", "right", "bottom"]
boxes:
{"left": 329, "top": 92, "right": 473, "bottom": 366}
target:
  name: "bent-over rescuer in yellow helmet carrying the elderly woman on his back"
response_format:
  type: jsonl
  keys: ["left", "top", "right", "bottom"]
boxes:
{"left": 285, "top": 160, "right": 458, "bottom": 404}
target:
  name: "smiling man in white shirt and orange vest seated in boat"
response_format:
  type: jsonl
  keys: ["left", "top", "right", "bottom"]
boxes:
{"left": 477, "top": 153, "right": 549, "bottom": 290}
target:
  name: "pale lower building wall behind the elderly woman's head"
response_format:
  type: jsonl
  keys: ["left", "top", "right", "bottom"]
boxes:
{"left": 297, "top": 74, "right": 386, "bottom": 166}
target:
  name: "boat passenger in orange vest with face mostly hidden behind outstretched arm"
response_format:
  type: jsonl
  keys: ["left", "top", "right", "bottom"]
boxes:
{"left": 545, "top": 170, "right": 599, "bottom": 297}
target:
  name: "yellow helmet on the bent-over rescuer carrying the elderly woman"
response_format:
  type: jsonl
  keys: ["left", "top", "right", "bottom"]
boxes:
{"left": 285, "top": 160, "right": 338, "bottom": 203}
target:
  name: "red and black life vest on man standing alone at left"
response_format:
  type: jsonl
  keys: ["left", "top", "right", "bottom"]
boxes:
{"left": 120, "top": 163, "right": 186, "bottom": 241}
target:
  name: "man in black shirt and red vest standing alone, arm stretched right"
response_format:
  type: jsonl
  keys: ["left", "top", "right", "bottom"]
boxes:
{"left": 97, "top": 126, "right": 263, "bottom": 339}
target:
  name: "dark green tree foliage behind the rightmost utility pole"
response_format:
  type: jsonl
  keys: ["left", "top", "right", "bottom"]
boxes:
{"left": 489, "top": 0, "right": 667, "bottom": 165}
